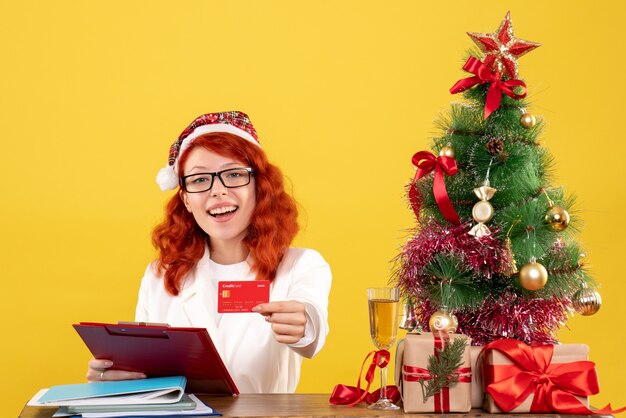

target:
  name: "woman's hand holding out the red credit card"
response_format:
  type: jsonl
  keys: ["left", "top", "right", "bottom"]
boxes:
{"left": 252, "top": 300, "right": 306, "bottom": 344}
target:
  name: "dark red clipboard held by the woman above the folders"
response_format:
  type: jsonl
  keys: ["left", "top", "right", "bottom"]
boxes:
{"left": 73, "top": 322, "right": 239, "bottom": 395}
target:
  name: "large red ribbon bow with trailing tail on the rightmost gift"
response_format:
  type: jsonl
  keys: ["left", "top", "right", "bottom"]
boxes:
{"left": 483, "top": 339, "right": 626, "bottom": 415}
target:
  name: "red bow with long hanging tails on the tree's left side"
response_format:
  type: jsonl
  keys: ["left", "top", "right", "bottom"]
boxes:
{"left": 409, "top": 151, "right": 461, "bottom": 225}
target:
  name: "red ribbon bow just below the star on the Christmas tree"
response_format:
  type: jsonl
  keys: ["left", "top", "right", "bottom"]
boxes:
{"left": 450, "top": 57, "right": 526, "bottom": 119}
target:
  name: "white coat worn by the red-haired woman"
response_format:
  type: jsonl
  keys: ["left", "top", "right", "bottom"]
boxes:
{"left": 135, "top": 248, "right": 331, "bottom": 393}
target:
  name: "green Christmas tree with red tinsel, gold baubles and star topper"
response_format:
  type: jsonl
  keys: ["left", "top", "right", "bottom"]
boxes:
{"left": 394, "top": 13, "right": 601, "bottom": 345}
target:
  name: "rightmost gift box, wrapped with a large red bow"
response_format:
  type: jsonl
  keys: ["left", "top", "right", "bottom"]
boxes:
{"left": 479, "top": 339, "right": 599, "bottom": 414}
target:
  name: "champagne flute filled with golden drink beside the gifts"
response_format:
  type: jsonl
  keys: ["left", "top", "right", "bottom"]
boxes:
{"left": 367, "top": 287, "right": 400, "bottom": 410}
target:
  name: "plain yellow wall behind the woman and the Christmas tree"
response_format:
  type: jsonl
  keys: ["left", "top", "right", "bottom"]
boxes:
{"left": 0, "top": 0, "right": 626, "bottom": 416}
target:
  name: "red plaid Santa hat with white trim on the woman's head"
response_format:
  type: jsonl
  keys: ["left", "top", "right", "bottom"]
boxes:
{"left": 157, "top": 112, "right": 261, "bottom": 191}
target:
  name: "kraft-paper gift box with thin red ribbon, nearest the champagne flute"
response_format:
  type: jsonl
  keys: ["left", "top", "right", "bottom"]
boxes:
{"left": 395, "top": 332, "right": 472, "bottom": 413}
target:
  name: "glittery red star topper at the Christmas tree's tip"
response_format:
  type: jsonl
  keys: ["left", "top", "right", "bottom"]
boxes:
{"left": 467, "top": 12, "right": 541, "bottom": 78}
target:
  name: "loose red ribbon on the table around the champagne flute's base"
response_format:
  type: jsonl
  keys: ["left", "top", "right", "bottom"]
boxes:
{"left": 330, "top": 350, "right": 400, "bottom": 406}
